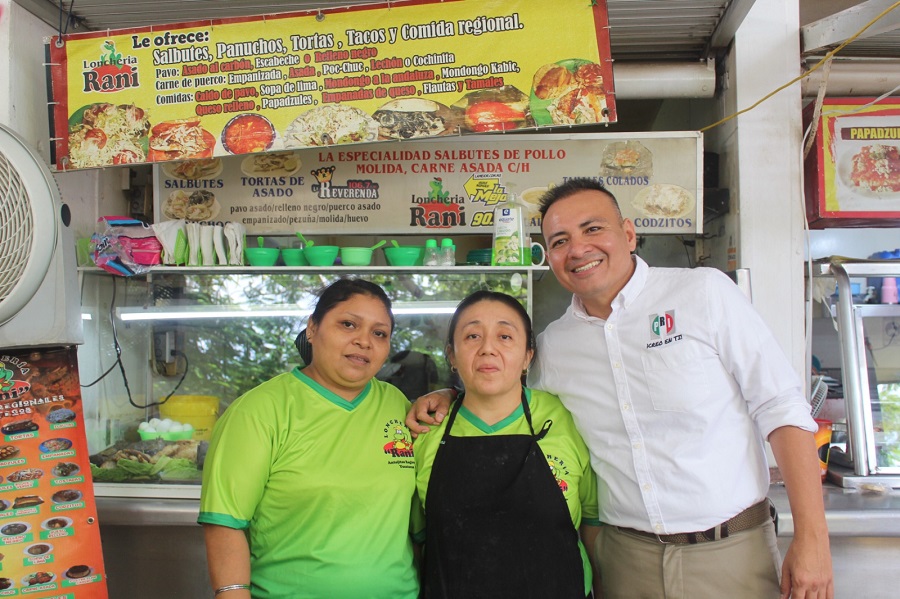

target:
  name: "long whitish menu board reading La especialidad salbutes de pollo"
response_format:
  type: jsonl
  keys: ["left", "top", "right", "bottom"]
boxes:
{"left": 153, "top": 131, "right": 703, "bottom": 235}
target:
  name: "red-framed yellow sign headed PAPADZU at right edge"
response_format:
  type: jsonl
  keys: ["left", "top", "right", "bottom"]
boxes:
{"left": 806, "top": 98, "right": 900, "bottom": 227}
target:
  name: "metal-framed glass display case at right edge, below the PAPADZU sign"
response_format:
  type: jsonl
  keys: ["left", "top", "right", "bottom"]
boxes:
{"left": 813, "top": 259, "right": 900, "bottom": 488}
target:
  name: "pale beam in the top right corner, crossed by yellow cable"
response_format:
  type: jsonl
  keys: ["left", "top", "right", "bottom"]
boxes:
{"left": 800, "top": 0, "right": 900, "bottom": 54}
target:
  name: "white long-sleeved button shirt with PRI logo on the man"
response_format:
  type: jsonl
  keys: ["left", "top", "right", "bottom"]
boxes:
{"left": 529, "top": 256, "right": 816, "bottom": 534}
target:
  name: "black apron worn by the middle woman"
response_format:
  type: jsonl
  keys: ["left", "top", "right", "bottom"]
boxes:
{"left": 424, "top": 390, "right": 585, "bottom": 599}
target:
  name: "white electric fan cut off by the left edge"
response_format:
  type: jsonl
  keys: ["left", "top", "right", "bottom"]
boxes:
{"left": 0, "top": 125, "right": 83, "bottom": 350}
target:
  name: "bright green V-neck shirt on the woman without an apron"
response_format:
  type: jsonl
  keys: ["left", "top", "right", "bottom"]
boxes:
{"left": 197, "top": 368, "right": 419, "bottom": 599}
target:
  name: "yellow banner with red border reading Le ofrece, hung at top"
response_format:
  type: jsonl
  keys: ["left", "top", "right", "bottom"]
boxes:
{"left": 48, "top": 0, "right": 616, "bottom": 170}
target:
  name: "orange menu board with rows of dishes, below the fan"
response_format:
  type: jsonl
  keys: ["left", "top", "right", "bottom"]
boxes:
{"left": 0, "top": 347, "right": 107, "bottom": 599}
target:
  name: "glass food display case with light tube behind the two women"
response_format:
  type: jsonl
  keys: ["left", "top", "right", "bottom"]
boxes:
{"left": 78, "top": 266, "right": 548, "bottom": 506}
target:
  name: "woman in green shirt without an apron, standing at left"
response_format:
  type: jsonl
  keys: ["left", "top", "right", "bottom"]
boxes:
{"left": 198, "top": 279, "right": 419, "bottom": 599}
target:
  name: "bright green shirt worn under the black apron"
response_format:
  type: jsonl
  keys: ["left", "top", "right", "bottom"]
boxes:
{"left": 415, "top": 388, "right": 600, "bottom": 595}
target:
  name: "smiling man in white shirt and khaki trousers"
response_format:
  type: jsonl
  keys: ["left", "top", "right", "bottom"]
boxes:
{"left": 410, "top": 179, "right": 834, "bottom": 599}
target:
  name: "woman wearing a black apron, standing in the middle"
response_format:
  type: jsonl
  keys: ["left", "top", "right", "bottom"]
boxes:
{"left": 415, "top": 291, "right": 599, "bottom": 599}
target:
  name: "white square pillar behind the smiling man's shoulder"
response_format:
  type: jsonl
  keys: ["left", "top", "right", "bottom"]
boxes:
{"left": 703, "top": 0, "right": 807, "bottom": 376}
